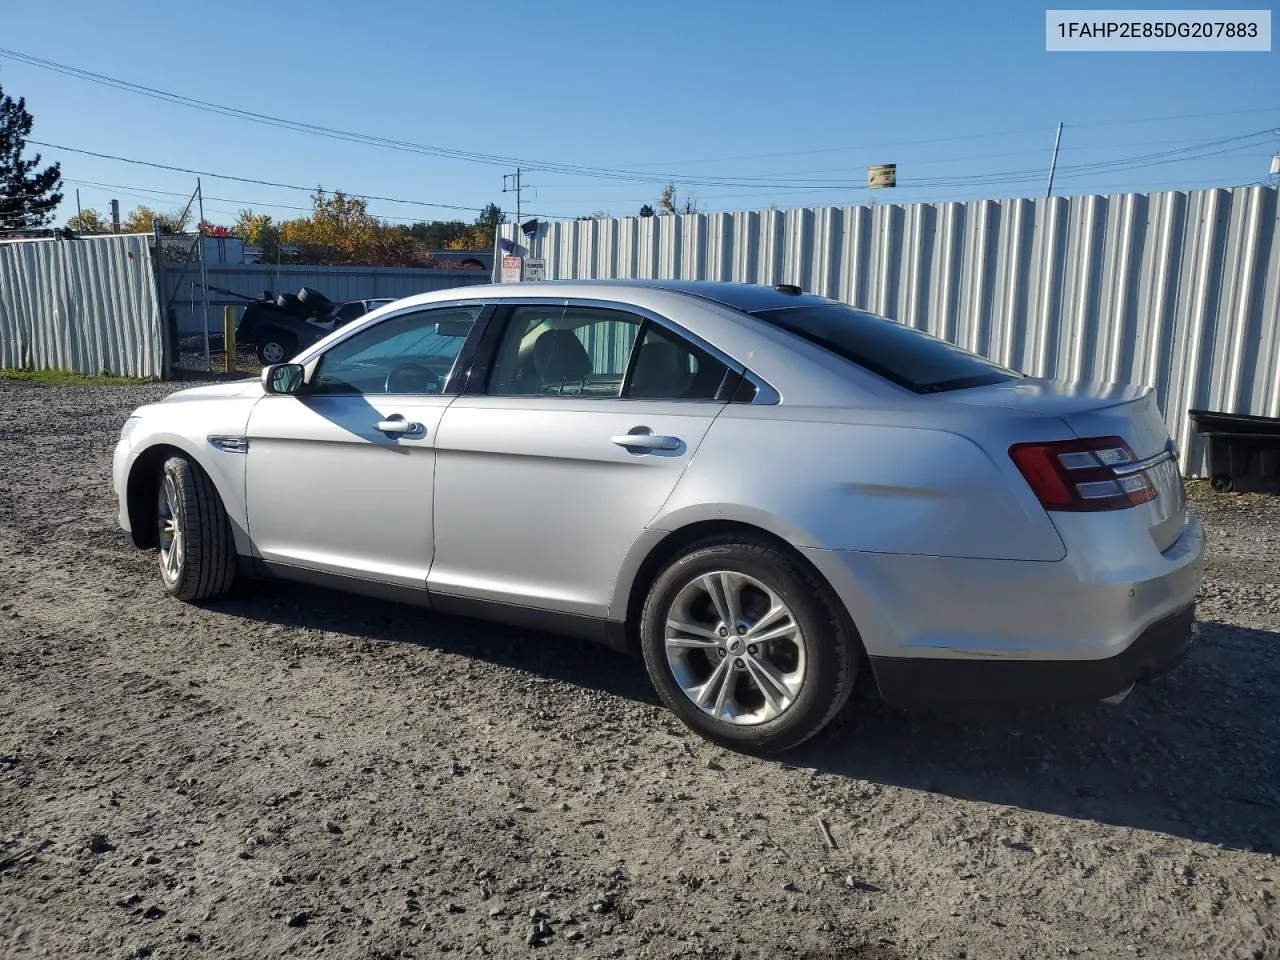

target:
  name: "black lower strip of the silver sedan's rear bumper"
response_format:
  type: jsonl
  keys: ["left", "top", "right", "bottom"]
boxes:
{"left": 870, "top": 607, "right": 1198, "bottom": 705}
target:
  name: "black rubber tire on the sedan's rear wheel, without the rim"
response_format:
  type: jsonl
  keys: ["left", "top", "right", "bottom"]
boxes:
{"left": 640, "top": 535, "right": 860, "bottom": 753}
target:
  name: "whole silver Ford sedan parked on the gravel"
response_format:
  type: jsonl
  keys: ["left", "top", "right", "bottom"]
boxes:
{"left": 114, "top": 280, "right": 1203, "bottom": 751}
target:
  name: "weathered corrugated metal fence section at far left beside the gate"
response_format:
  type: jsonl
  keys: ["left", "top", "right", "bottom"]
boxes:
{"left": 0, "top": 236, "right": 164, "bottom": 376}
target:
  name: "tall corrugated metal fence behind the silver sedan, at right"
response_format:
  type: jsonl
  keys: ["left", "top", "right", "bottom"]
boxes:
{"left": 500, "top": 187, "right": 1280, "bottom": 470}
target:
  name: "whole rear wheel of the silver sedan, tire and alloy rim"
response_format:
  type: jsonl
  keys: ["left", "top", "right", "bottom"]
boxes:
{"left": 640, "top": 536, "right": 858, "bottom": 753}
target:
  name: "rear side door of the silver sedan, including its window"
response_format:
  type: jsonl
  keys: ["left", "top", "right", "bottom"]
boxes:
{"left": 428, "top": 300, "right": 741, "bottom": 617}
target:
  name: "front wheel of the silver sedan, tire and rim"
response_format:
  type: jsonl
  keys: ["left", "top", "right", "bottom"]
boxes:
{"left": 156, "top": 457, "right": 237, "bottom": 600}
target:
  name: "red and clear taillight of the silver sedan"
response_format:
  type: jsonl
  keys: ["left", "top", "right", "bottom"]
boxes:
{"left": 1009, "top": 436, "right": 1156, "bottom": 511}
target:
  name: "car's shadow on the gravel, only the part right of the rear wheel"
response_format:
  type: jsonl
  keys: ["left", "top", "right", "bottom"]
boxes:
{"left": 787, "top": 623, "right": 1280, "bottom": 854}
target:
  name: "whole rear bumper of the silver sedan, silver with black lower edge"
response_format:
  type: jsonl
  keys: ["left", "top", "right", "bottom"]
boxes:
{"left": 804, "top": 513, "right": 1204, "bottom": 703}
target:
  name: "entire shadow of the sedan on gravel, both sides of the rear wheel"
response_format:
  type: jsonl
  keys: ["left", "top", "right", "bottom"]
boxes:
{"left": 210, "top": 584, "right": 1280, "bottom": 854}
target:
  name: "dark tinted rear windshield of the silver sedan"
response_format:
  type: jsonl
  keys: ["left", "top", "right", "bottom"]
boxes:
{"left": 753, "top": 303, "right": 1021, "bottom": 393}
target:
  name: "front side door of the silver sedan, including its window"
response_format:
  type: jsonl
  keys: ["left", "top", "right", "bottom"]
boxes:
{"left": 246, "top": 302, "right": 485, "bottom": 589}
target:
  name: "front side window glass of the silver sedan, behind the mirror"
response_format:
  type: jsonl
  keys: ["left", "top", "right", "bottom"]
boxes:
{"left": 311, "top": 303, "right": 484, "bottom": 396}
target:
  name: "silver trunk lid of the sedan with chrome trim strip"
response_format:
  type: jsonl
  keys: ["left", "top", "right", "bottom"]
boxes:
{"left": 945, "top": 378, "right": 1187, "bottom": 550}
